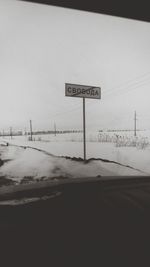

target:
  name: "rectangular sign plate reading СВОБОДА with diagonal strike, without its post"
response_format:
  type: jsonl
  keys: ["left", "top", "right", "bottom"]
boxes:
{"left": 65, "top": 83, "right": 101, "bottom": 99}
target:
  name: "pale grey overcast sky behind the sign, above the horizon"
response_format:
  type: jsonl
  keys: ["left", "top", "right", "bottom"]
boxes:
{"left": 0, "top": 0, "right": 150, "bottom": 130}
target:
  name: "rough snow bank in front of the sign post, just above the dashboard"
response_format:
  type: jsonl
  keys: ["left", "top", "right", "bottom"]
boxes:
{"left": 0, "top": 143, "right": 146, "bottom": 182}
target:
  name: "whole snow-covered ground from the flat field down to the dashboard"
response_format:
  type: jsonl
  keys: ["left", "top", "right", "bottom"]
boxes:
{"left": 0, "top": 132, "right": 150, "bottom": 185}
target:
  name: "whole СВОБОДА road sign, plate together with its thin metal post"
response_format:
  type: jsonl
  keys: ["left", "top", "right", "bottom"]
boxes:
{"left": 65, "top": 83, "right": 101, "bottom": 162}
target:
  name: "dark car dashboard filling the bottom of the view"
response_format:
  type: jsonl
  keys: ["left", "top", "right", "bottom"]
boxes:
{"left": 0, "top": 177, "right": 150, "bottom": 267}
